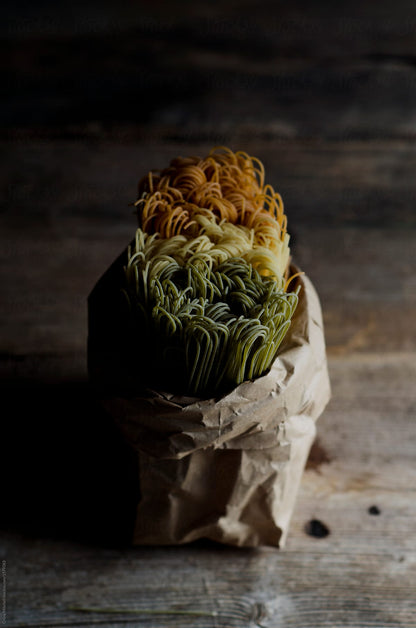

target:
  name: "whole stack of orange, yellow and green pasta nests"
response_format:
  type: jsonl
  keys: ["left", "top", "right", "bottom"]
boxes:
{"left": 124, "top": 147, "right": 298, "bottom": 396}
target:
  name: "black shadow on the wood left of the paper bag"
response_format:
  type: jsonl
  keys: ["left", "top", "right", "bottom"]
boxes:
{"left": 0, "top": 380, "right": 139, "bottom": 546}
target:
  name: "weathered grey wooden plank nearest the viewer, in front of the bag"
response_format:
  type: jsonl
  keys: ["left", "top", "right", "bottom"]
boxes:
{"left": 1, "top": 536, "right": 415, "bottom": 628}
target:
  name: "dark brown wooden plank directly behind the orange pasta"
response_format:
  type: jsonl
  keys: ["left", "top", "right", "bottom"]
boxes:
{"left": 1, "top": 139, "right": 416, "bottom": 231}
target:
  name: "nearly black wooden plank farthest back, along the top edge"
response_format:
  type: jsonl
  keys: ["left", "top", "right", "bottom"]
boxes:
{"left": 2, "top": 0, "right": 416, "bottom": 143}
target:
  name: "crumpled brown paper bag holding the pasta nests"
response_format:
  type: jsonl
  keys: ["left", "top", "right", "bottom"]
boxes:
{"left": 88, "top": 254, "right": 330, "bottom": 547}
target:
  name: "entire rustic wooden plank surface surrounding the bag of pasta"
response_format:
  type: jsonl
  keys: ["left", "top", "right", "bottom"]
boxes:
{"left": 0, "top": 0, "right": 416, "bottom": 628}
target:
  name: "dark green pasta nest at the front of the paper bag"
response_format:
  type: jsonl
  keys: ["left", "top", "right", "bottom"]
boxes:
{"left": 124, "top": 230, "right": 298, "bottom": 397}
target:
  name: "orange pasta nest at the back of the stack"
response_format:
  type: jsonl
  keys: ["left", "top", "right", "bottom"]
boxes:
{"left": 135, "top": 147, "right": 289, "bottom": 276}
